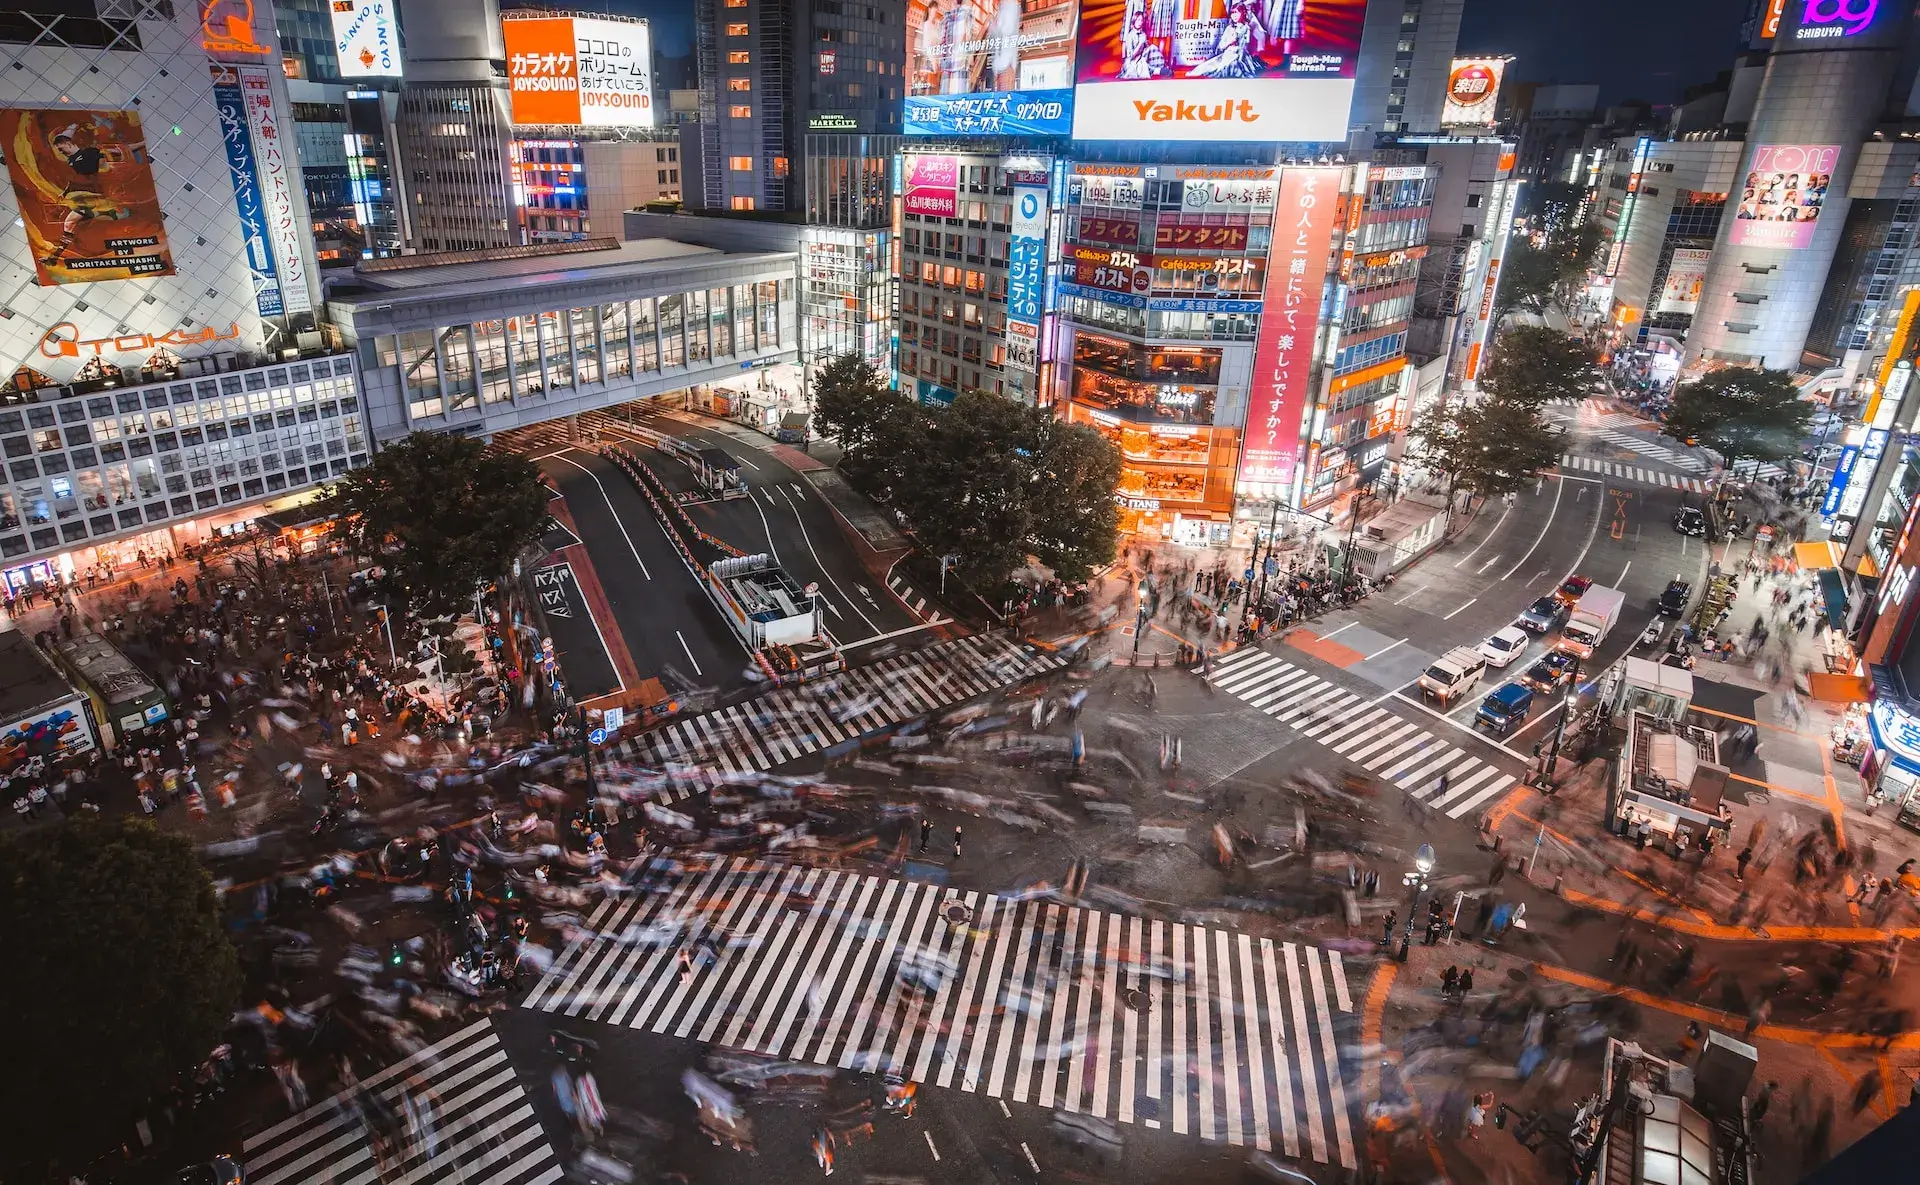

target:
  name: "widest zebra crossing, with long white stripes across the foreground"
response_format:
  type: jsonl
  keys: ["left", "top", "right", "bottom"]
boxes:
{"left": 522, "top": 859, "right": 1357, "bottom": 1168}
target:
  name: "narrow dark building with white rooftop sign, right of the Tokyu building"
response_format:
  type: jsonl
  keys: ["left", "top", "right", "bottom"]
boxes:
{"left": 275, "top": 0, "right": 407, "bottom": 267}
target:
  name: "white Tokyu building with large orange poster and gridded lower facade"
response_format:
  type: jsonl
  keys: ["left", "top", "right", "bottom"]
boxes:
{"left": 0, "top": 0, "right": 367, "bottom": 590}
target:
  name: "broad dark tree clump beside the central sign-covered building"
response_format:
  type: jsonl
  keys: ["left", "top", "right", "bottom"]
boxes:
{"left": 814, "top": 359, "right": 1119, "bottom": 588}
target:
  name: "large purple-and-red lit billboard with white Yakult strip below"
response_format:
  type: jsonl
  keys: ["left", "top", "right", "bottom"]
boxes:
{"left": 1073, "top": 0, "right": 1367, "bottom": 142}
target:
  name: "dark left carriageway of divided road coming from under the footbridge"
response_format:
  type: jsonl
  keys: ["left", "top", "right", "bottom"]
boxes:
{"left": 540, "top": 449, "right": 747, "bottom": 691}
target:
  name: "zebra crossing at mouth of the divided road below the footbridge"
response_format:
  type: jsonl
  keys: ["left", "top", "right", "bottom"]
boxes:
{"left": 611, "top": 634, "right": 1064, "bottom": 774}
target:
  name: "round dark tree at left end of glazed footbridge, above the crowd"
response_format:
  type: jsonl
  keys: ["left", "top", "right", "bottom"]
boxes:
{"left": 328, "top": 432, "right": 549, "bottom": 617}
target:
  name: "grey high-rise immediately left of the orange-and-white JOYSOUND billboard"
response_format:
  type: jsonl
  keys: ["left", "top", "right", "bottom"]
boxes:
{"left": 396, "top": 0, "right": 520, "bottom": 252}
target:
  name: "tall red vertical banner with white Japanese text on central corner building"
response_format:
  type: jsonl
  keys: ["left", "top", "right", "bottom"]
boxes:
{"left": 1240, "top": 169, "right": 1344, "bottom": 486}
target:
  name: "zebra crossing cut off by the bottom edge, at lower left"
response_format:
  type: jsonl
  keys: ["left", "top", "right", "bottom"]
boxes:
{"left": 242, "top": 1020, "right": 566, "bottom": 1185}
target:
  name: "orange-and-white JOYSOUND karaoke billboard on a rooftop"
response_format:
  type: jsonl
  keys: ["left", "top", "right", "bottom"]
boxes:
{"left": 501, "top": 17, "right": 653, "bottom": 127}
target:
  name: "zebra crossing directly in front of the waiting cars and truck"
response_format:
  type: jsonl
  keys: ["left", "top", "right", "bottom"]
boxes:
{"left": 1208, "top": 647, "right": 1519, "bottom": 818}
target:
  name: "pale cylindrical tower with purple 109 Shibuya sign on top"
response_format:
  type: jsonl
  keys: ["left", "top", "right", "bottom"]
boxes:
{"left": 1686, "top": 4, "right": 1914, "bottom": 369}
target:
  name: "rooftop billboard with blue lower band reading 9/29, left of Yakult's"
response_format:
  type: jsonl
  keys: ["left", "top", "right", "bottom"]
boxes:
{"left": 902, "top": 0, "right": 1077, "bottom": 136}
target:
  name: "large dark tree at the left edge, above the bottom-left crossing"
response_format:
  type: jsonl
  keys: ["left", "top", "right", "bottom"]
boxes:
{"left": 0, "top": 818, "right": 240, "bottom": 1179}
